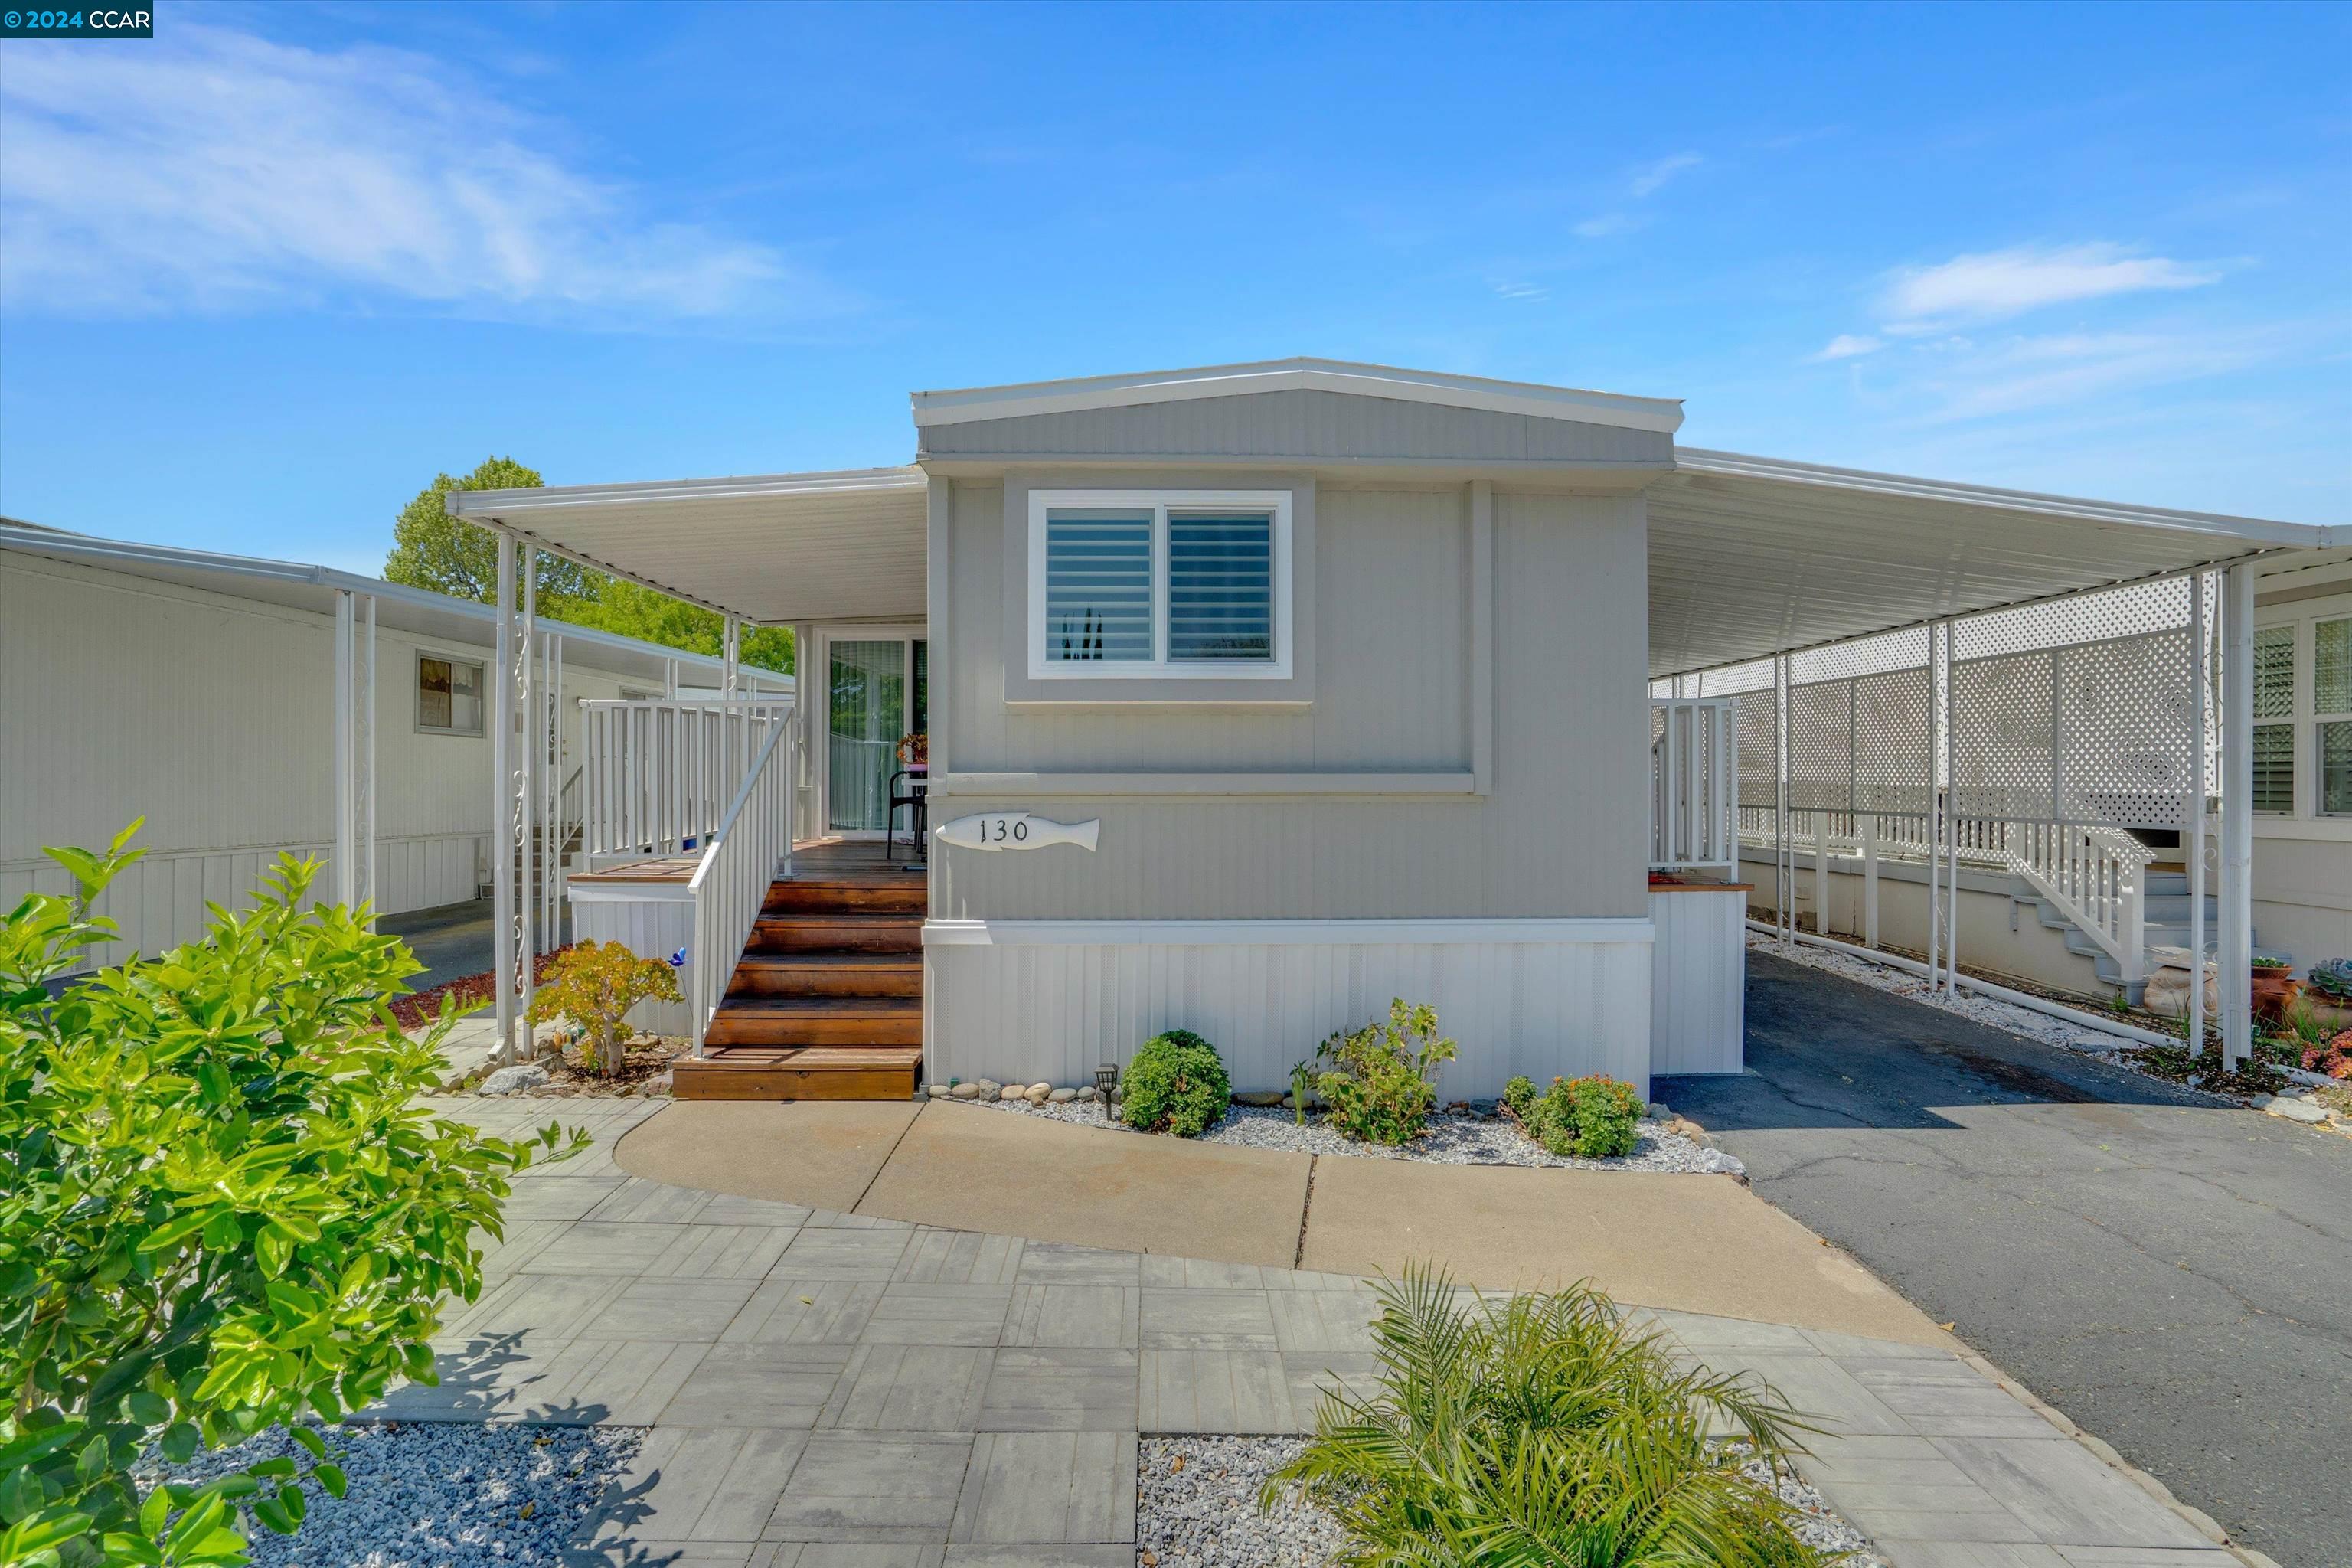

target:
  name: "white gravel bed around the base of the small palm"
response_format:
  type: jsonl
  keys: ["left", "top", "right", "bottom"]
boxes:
{"left": 1136, "top": 1436, "right": 1886, "bottom": 1568}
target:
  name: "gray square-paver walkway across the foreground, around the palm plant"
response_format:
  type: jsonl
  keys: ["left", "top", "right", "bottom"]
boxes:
{"left": 395, "top": 1100, "right": 2234, "bottom": 1568}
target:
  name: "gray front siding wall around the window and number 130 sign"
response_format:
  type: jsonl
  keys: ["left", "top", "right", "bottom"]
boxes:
{"left": 932, "top": 477, "right": 1648, "bottom": 920}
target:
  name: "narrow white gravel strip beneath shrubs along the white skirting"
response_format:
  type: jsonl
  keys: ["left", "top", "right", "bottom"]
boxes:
{"left": 948, "top": 1100, "right": 1747, "bottom": 1175}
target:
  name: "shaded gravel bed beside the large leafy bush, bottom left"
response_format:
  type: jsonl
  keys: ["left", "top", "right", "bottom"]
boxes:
{"left": 147, "top": 1423, "right": 645, "bottom": 1568}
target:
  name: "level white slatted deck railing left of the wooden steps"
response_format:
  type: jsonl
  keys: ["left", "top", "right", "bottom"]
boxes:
{"left": 581, "top": 698, "right": 792, "bottom": 867}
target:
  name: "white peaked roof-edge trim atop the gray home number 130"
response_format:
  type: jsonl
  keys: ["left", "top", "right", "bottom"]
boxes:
{"left": 908, "top": 358, "right": 1681, "bottom": 435}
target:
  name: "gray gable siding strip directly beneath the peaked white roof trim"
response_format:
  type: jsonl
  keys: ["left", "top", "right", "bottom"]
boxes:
{"left": 917, "top": 393, "right": 1674, "bottom": 468}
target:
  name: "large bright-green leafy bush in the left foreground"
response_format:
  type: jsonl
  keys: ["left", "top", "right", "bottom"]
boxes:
{"left": 0, "top": 823, "right": 583, "bottom": 1568}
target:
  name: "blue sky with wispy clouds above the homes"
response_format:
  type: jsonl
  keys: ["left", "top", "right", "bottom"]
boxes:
{"left": 0, "top": 0, "right": 2352, "bottom": 569}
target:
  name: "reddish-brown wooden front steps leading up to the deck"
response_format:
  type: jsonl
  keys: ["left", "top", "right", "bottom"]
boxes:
{"left": 671, "top": 844, "right": 929, "bottom": 1100}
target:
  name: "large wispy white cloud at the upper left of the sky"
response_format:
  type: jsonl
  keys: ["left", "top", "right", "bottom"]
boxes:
{"left": 0, "top": 24, "right": 849, "bottom": 325}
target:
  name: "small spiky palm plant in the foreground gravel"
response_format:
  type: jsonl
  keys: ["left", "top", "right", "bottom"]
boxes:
{"left": 1259, "top": 1267, "right": 1834, "bottom": 1568}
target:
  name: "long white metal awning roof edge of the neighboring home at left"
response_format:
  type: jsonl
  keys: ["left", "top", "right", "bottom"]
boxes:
{"left": 0, "top": 520, "right": 792, "bottom": 687}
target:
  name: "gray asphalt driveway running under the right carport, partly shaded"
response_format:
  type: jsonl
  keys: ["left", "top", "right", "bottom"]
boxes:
{"left": 1654, "top": 952, "right": 2352, "bottom": 1568}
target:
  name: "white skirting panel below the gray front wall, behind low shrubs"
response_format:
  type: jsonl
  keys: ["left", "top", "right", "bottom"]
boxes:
{"left": 924, "top": 920, "right": 1651, "bottom": 1100}
